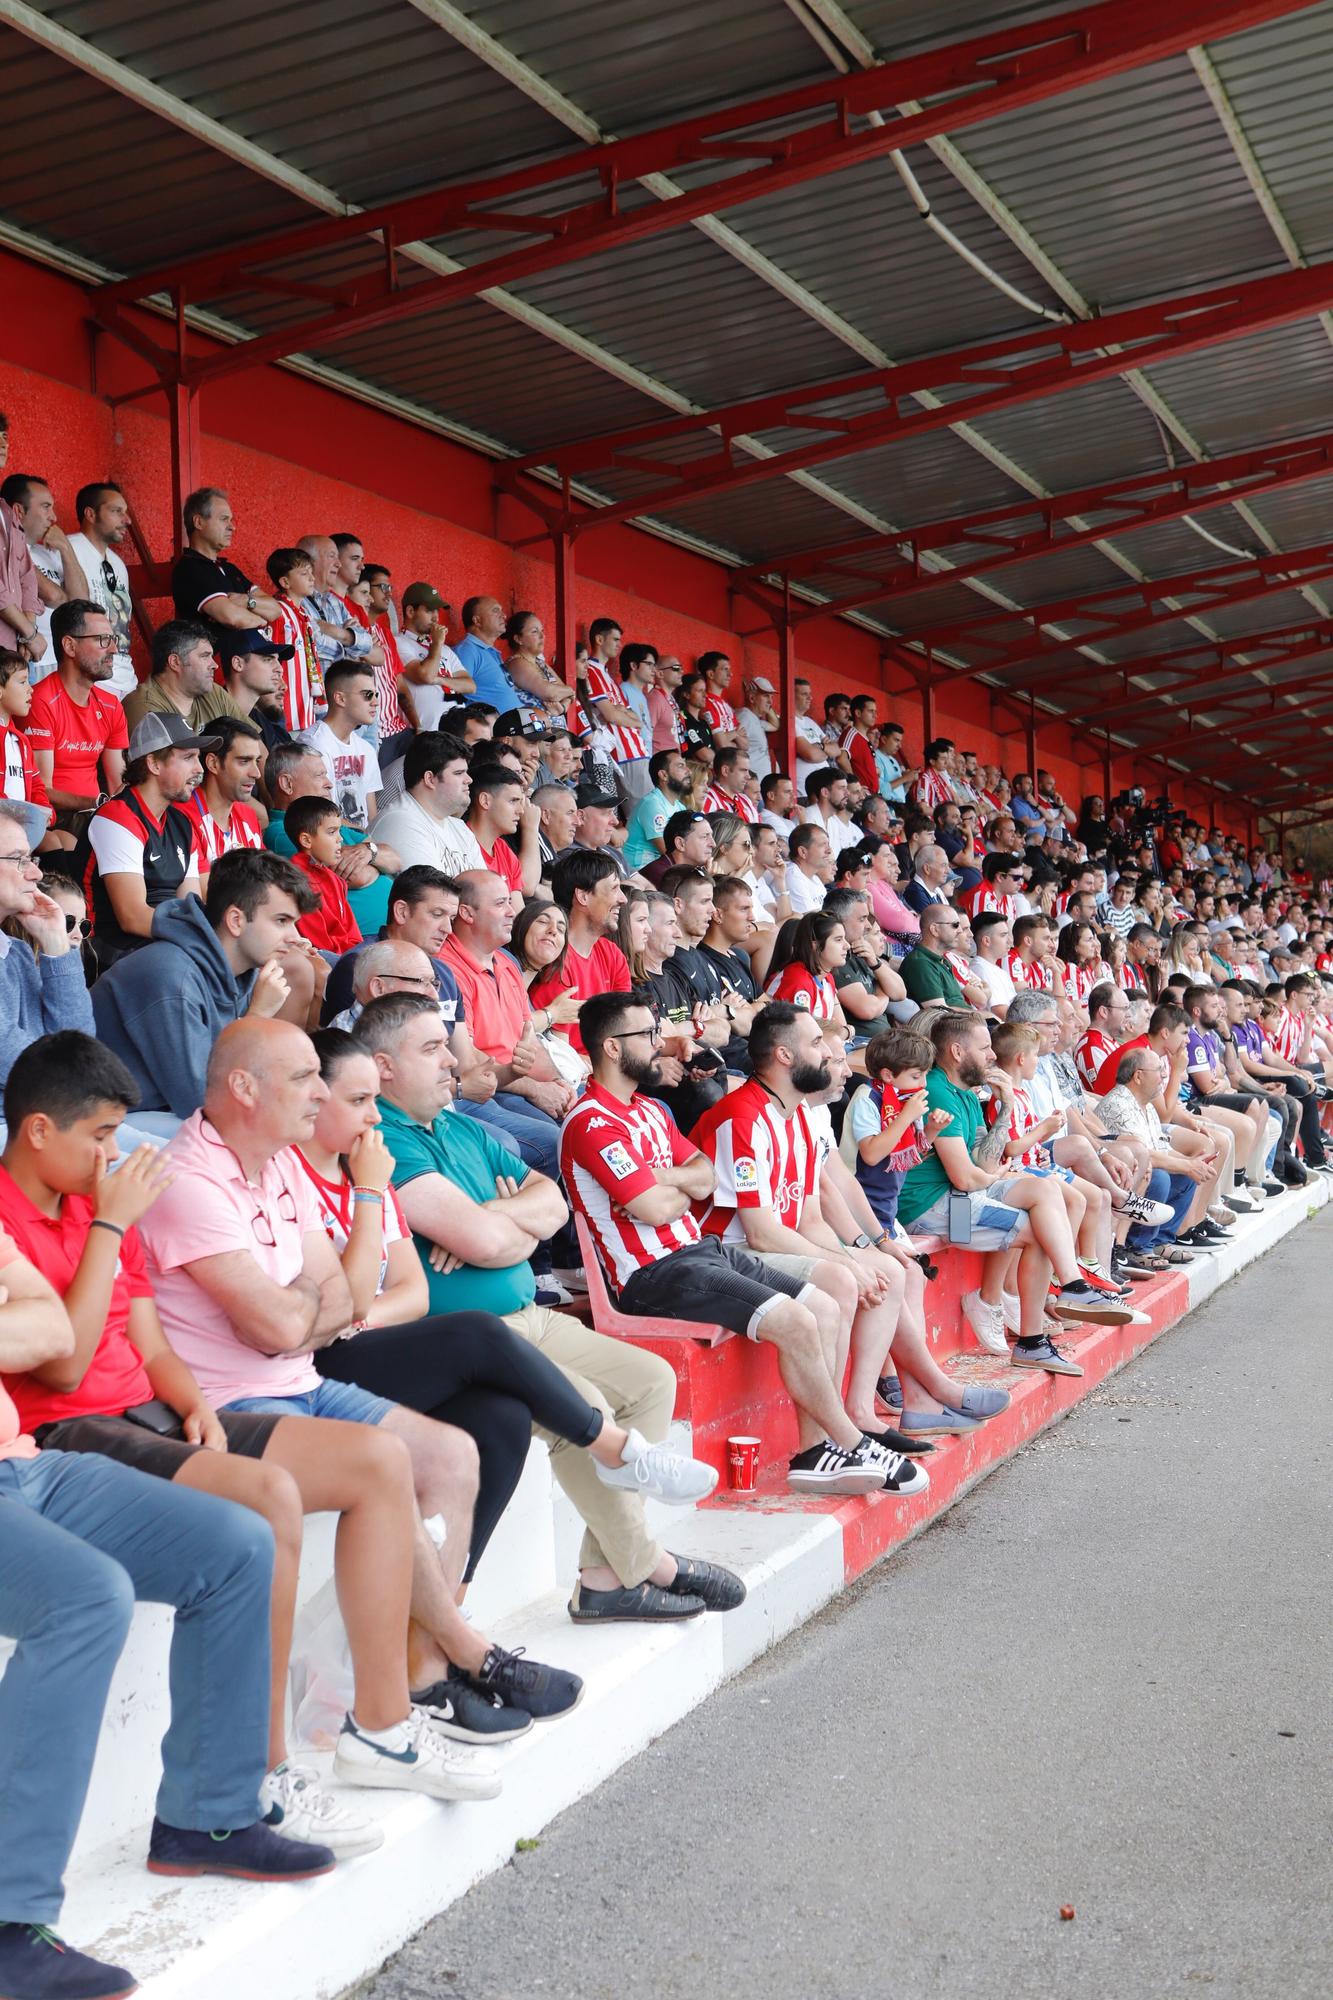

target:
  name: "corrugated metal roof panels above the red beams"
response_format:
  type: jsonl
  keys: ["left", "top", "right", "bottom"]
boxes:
{"left": 0, "top": 0, "right": 1333, "bottom": 796}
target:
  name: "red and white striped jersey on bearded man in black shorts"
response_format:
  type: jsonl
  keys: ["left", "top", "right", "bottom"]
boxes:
{"left": 560, "top": 1084, "right": 699, "bottom": 1292}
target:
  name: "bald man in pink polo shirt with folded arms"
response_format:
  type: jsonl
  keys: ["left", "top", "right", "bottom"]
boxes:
{"left": 140, "top": 1016, "right": 580, "bottom": 1728}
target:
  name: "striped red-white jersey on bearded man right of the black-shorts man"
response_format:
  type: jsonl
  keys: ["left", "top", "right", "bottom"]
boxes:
{"left": 691, "top": 1078, "right": 819, "bottom": 1244}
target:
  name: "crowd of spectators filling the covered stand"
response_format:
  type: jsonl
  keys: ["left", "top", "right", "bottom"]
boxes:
{"left": 0, "top": 446, "right": 1333, "bottom": 2000}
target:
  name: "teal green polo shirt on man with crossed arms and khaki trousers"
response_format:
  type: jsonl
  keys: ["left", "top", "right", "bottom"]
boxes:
{"left": 378, "top": 1098, "right": 536, "bottom": 1316}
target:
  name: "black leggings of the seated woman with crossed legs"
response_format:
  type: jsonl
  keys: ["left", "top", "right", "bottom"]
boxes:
{"left": 314, "top": 1312, "right": 604, "bottom": 1582}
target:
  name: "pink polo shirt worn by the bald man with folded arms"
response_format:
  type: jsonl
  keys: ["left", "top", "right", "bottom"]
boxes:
{"left": 138, "top": 1112, "right": 324, "bottom": 1408}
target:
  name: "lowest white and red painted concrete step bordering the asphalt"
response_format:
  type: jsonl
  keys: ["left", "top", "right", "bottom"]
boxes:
{"left": 52, "top": 1182, "right": 1329, "bottom": 2000}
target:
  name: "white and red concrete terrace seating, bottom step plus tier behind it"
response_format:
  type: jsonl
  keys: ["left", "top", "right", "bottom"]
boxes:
{"left": 15, "top": 1180, "right": 1333, "bottom": 2000}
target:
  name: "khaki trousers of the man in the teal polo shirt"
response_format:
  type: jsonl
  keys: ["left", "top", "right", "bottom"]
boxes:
{"left": 504, "top": 1306, "right": 677, "bottom": 1590}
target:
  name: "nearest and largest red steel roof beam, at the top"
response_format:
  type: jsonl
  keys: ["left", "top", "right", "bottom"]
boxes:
{"left": 94, "top": 0, "right": 1315, "bottom": 394}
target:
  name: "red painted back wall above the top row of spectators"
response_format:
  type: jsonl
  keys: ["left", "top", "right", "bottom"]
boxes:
{"left": 0, "top": 252, "right": 1243, "bottom": 830}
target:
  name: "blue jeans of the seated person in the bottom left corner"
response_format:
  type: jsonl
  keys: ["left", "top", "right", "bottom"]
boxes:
{"left": 0, "top": 1452, "right": 272, "bottom": 1924}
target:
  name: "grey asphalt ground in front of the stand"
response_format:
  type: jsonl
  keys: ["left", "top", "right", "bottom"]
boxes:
{"left": 358, "top": 1210, "right": 1333, "bottom": 2000}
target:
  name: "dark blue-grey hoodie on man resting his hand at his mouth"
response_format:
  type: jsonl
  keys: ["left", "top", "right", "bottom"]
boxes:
{"left": 92, "top": 896, "right": 256, "bottom": 1118}
